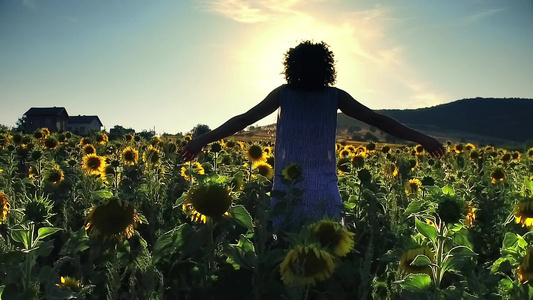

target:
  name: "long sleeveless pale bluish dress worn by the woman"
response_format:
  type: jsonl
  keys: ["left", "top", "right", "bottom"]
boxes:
{"left": 270, "top": 85, "right": 342, "bottom": 226}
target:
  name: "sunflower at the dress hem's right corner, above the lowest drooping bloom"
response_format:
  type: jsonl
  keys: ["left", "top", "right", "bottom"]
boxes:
{"left": 310, "top": 220, "right": 354, "bottom": 257}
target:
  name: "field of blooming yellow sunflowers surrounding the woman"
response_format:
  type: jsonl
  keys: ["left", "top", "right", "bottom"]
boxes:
{"left": 0, "top": 128, "right": 533, "bottom": 300}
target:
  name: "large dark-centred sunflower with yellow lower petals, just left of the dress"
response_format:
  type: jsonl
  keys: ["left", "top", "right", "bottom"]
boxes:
{"left": 182, "top": 181, "right": 233, "bottom": 223}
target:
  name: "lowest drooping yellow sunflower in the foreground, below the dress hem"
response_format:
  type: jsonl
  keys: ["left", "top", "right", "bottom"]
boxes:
{"left": 280, "top": 245, "right": 335, "bottom": 285}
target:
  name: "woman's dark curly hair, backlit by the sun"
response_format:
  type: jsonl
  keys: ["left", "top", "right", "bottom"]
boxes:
{"left": 283, "top": 41, "right": 337, "bottom": 90}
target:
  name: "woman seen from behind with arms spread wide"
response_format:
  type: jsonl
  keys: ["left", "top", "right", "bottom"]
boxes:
{"left": 182, "top": 41, "right": 445, "bottom": 226}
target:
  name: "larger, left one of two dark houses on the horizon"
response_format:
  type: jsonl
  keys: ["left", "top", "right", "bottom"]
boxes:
{"left": 24, "top": 106, "right": 69, "bottom": 133}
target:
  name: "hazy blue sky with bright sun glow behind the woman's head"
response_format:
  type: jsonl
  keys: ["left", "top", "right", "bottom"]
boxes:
{"left": 0, "top": 0, "right": 533, "bottom": 134}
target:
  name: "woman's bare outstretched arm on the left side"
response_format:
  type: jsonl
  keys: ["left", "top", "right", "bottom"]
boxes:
{"left": 182, "top": 87, "right": 281, "bottom": 161}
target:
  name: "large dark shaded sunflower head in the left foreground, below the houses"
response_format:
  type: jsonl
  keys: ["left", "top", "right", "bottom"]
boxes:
{"left": 85, "top": 198, "right": 142, "bottom": 239}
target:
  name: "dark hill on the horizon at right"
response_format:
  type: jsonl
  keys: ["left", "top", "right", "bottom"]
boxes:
{"left": 337, "top": 97, "right": 533, "bottom": 143}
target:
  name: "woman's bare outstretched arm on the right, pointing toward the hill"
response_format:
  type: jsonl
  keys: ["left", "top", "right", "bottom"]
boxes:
{"left": 338, "top": 90, "right": 445, "bottom": 157}
